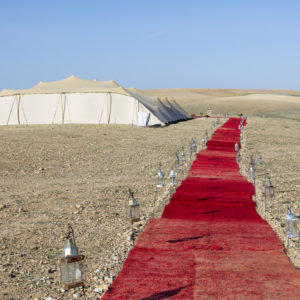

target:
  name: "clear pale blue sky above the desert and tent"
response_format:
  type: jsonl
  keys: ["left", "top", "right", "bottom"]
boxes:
{"left": 0, "top": 0, "right": 300, "bottom": 90}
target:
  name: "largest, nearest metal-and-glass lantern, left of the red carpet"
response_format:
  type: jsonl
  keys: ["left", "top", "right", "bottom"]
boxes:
{"left": 60, "top": 225, "right": 84, "bottom": 290}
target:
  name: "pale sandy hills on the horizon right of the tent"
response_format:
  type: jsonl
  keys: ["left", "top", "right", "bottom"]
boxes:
{"left": 142, "top": 89, "right": 300, "bottom": 120}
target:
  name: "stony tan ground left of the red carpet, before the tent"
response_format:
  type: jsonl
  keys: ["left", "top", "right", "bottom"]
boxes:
{"left": 0, "top": 119, "right": 216, "bottom": 300}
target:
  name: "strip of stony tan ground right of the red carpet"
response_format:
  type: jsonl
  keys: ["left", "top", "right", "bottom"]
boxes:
{"left": 241, "top": 117, "right": 300, "bottom": 268}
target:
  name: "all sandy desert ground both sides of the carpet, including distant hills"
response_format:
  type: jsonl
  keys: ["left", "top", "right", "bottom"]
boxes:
{"left": 0, "top": 89, "right": 300, "bottom": 300}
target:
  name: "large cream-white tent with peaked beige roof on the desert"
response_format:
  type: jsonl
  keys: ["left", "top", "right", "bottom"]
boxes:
{"left": 0, "top": 76, "right": 189, "bottom": 126}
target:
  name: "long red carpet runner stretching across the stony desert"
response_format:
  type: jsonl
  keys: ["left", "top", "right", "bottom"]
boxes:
{"left": 103, "top": 118, "right": 300, "bottom": 300}
